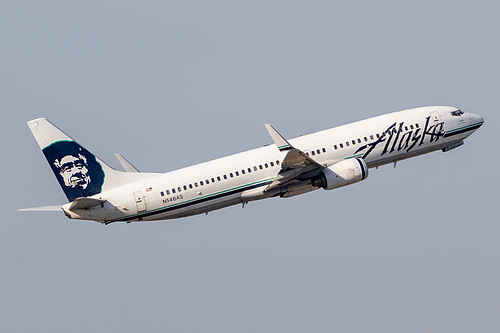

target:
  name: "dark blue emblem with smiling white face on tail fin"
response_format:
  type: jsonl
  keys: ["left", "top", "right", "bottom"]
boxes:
{"left": 43, "top": 141, "right": 104, "bottom": 201}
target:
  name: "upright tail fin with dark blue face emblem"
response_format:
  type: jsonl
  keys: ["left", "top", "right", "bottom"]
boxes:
{"left": 28, "top": 118, "right": 158, "bottom": 202}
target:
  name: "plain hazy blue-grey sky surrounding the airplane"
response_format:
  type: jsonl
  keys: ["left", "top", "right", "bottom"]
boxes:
{"left": 0, "top": 0, "right": 500, "bottom": 333}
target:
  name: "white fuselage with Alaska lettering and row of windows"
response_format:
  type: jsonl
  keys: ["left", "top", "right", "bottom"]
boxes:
{"left": 63, "top": 106, "right": 483, "bottom": 223}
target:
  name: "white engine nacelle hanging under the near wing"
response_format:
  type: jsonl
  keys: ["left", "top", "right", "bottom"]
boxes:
{"left": 312, "top": 158, "right": 368, "bottom": 190}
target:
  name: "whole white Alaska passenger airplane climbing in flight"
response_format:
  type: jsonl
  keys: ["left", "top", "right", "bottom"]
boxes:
{"left": 20, "top": 106, "right": 484, "bottom": 224}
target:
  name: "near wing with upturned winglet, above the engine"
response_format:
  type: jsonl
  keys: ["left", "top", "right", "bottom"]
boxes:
{"left": 264, "top": 124, "right": 325, "bottom": 191}
